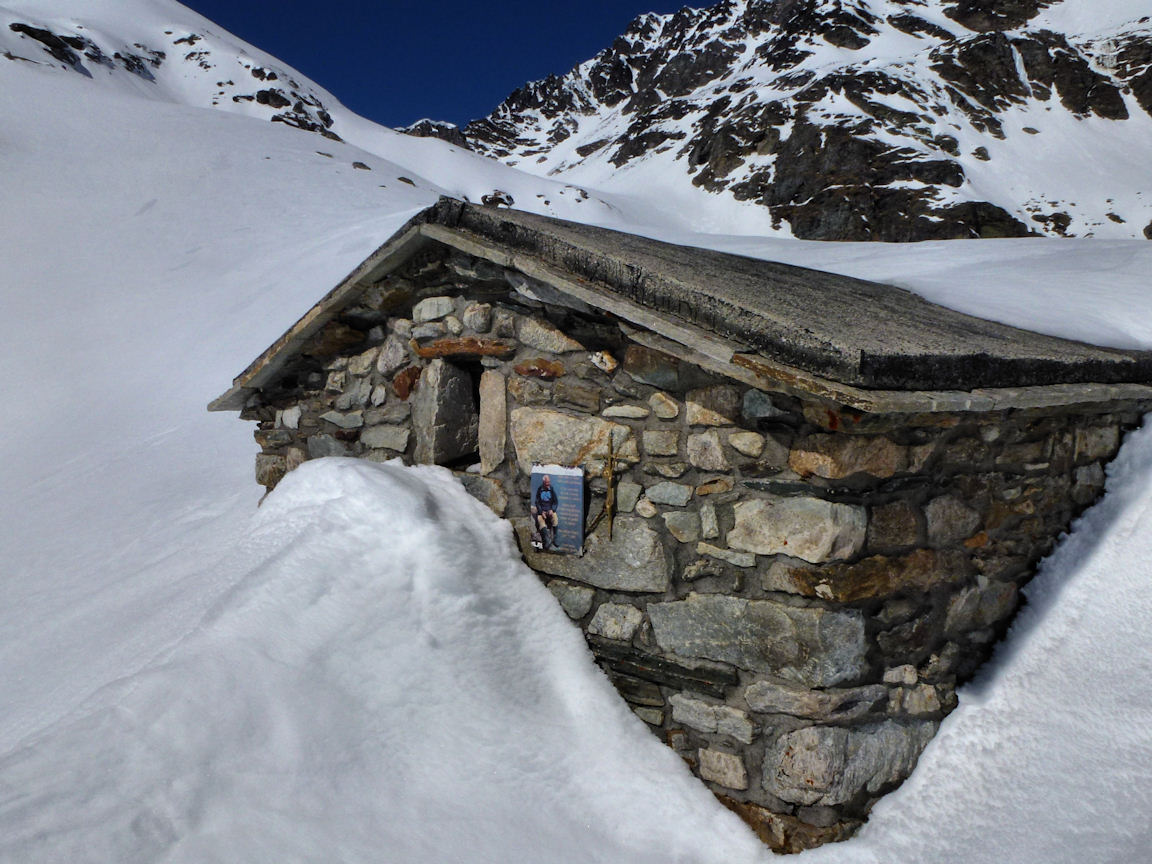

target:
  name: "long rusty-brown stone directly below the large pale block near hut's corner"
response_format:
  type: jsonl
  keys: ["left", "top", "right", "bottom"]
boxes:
{"left": 788, "top": 550, "right": 968, "bottom": 602}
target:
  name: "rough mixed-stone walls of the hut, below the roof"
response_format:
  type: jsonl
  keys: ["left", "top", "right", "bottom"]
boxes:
{"left": 243, "top": 246, "right": 1142, "bottom": 850}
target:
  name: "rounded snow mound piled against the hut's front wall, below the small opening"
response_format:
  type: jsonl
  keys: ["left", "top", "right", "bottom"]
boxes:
{"left": 0, "top": 458, "right": 768, "bottom": 864}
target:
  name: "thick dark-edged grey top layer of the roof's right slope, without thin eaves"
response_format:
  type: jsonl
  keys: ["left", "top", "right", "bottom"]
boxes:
{"left": 425, "top": 202, "right": 1152, "bottom": 389}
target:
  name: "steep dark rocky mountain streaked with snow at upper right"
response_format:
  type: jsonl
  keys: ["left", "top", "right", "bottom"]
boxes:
{"left": 446, "top": 0, "right": 1152, "bottom": 241}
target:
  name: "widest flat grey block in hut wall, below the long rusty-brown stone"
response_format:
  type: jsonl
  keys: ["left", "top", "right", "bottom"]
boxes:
{"left": 649, "top": 593, "right": 867, "bottom": 687}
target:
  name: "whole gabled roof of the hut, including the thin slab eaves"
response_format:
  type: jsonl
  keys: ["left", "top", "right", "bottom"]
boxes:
{"left": 210, "top": 198, "right": 1152, "bottom": 410}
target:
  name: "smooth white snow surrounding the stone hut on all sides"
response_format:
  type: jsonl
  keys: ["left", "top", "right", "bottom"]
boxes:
{"left": 0, "top": 0, "right": 1152, "bottom": 864}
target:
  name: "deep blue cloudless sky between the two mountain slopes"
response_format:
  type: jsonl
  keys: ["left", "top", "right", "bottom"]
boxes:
{"left": 182, "top": 0, "right": 681, "bottom": 126}
